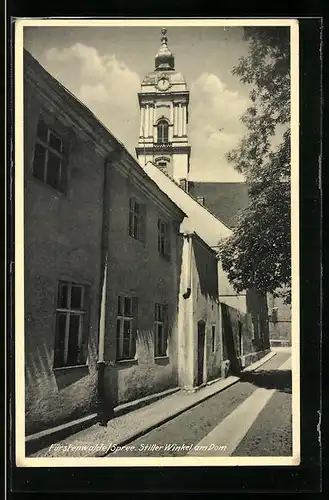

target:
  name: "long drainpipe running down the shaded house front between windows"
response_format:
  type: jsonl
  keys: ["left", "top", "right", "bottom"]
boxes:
{"left": 96, "top": 151, "right": 118, "bottom": 426}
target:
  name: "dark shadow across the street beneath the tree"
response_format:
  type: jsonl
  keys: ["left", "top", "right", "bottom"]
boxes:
{"left": 240, "top": 370, "right": 292, "bottom": 394}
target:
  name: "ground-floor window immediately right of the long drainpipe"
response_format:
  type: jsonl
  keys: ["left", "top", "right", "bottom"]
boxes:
{"left": 116, "top": 295, "right": 138, "bottom": 361}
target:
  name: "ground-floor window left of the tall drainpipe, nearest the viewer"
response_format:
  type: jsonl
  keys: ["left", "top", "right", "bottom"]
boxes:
{"left": 54, "top": 281, "right": 88, "bottom": 368}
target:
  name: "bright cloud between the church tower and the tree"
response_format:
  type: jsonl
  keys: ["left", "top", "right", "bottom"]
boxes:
{"left": 189, "top": 73, "right": 249, "bottom": 181}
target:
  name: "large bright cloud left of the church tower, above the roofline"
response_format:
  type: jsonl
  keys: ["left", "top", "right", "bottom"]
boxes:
{"left": 40, "top": 43, "right": 140, "bottom": 154}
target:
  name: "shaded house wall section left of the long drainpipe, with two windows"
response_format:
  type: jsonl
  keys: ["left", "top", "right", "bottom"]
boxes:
{"left": 24, "top": 49, "right": 106, "bottom": 434}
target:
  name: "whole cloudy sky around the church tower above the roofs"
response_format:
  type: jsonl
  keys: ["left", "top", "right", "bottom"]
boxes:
{"left": 24, "top": 26, "right": 255, "bottom": 182}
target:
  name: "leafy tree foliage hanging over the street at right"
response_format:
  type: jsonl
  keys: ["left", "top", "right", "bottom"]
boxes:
{"left": 220, "top": 27, "right": 291, "bottom": 302}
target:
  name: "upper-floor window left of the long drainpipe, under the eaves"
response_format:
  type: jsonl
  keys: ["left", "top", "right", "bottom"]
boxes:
{"left": 33, "top": 117, "right": 67, "bottom": 192}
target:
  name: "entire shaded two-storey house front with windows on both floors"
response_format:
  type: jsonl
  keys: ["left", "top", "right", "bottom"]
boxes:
{"left": 24, "top": 52, "right": 184, "bottom": 434}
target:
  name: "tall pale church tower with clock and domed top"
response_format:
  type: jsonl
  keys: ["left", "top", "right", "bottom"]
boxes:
{"left": 136, "top": 28, "right": 191, "bottom": 187}
